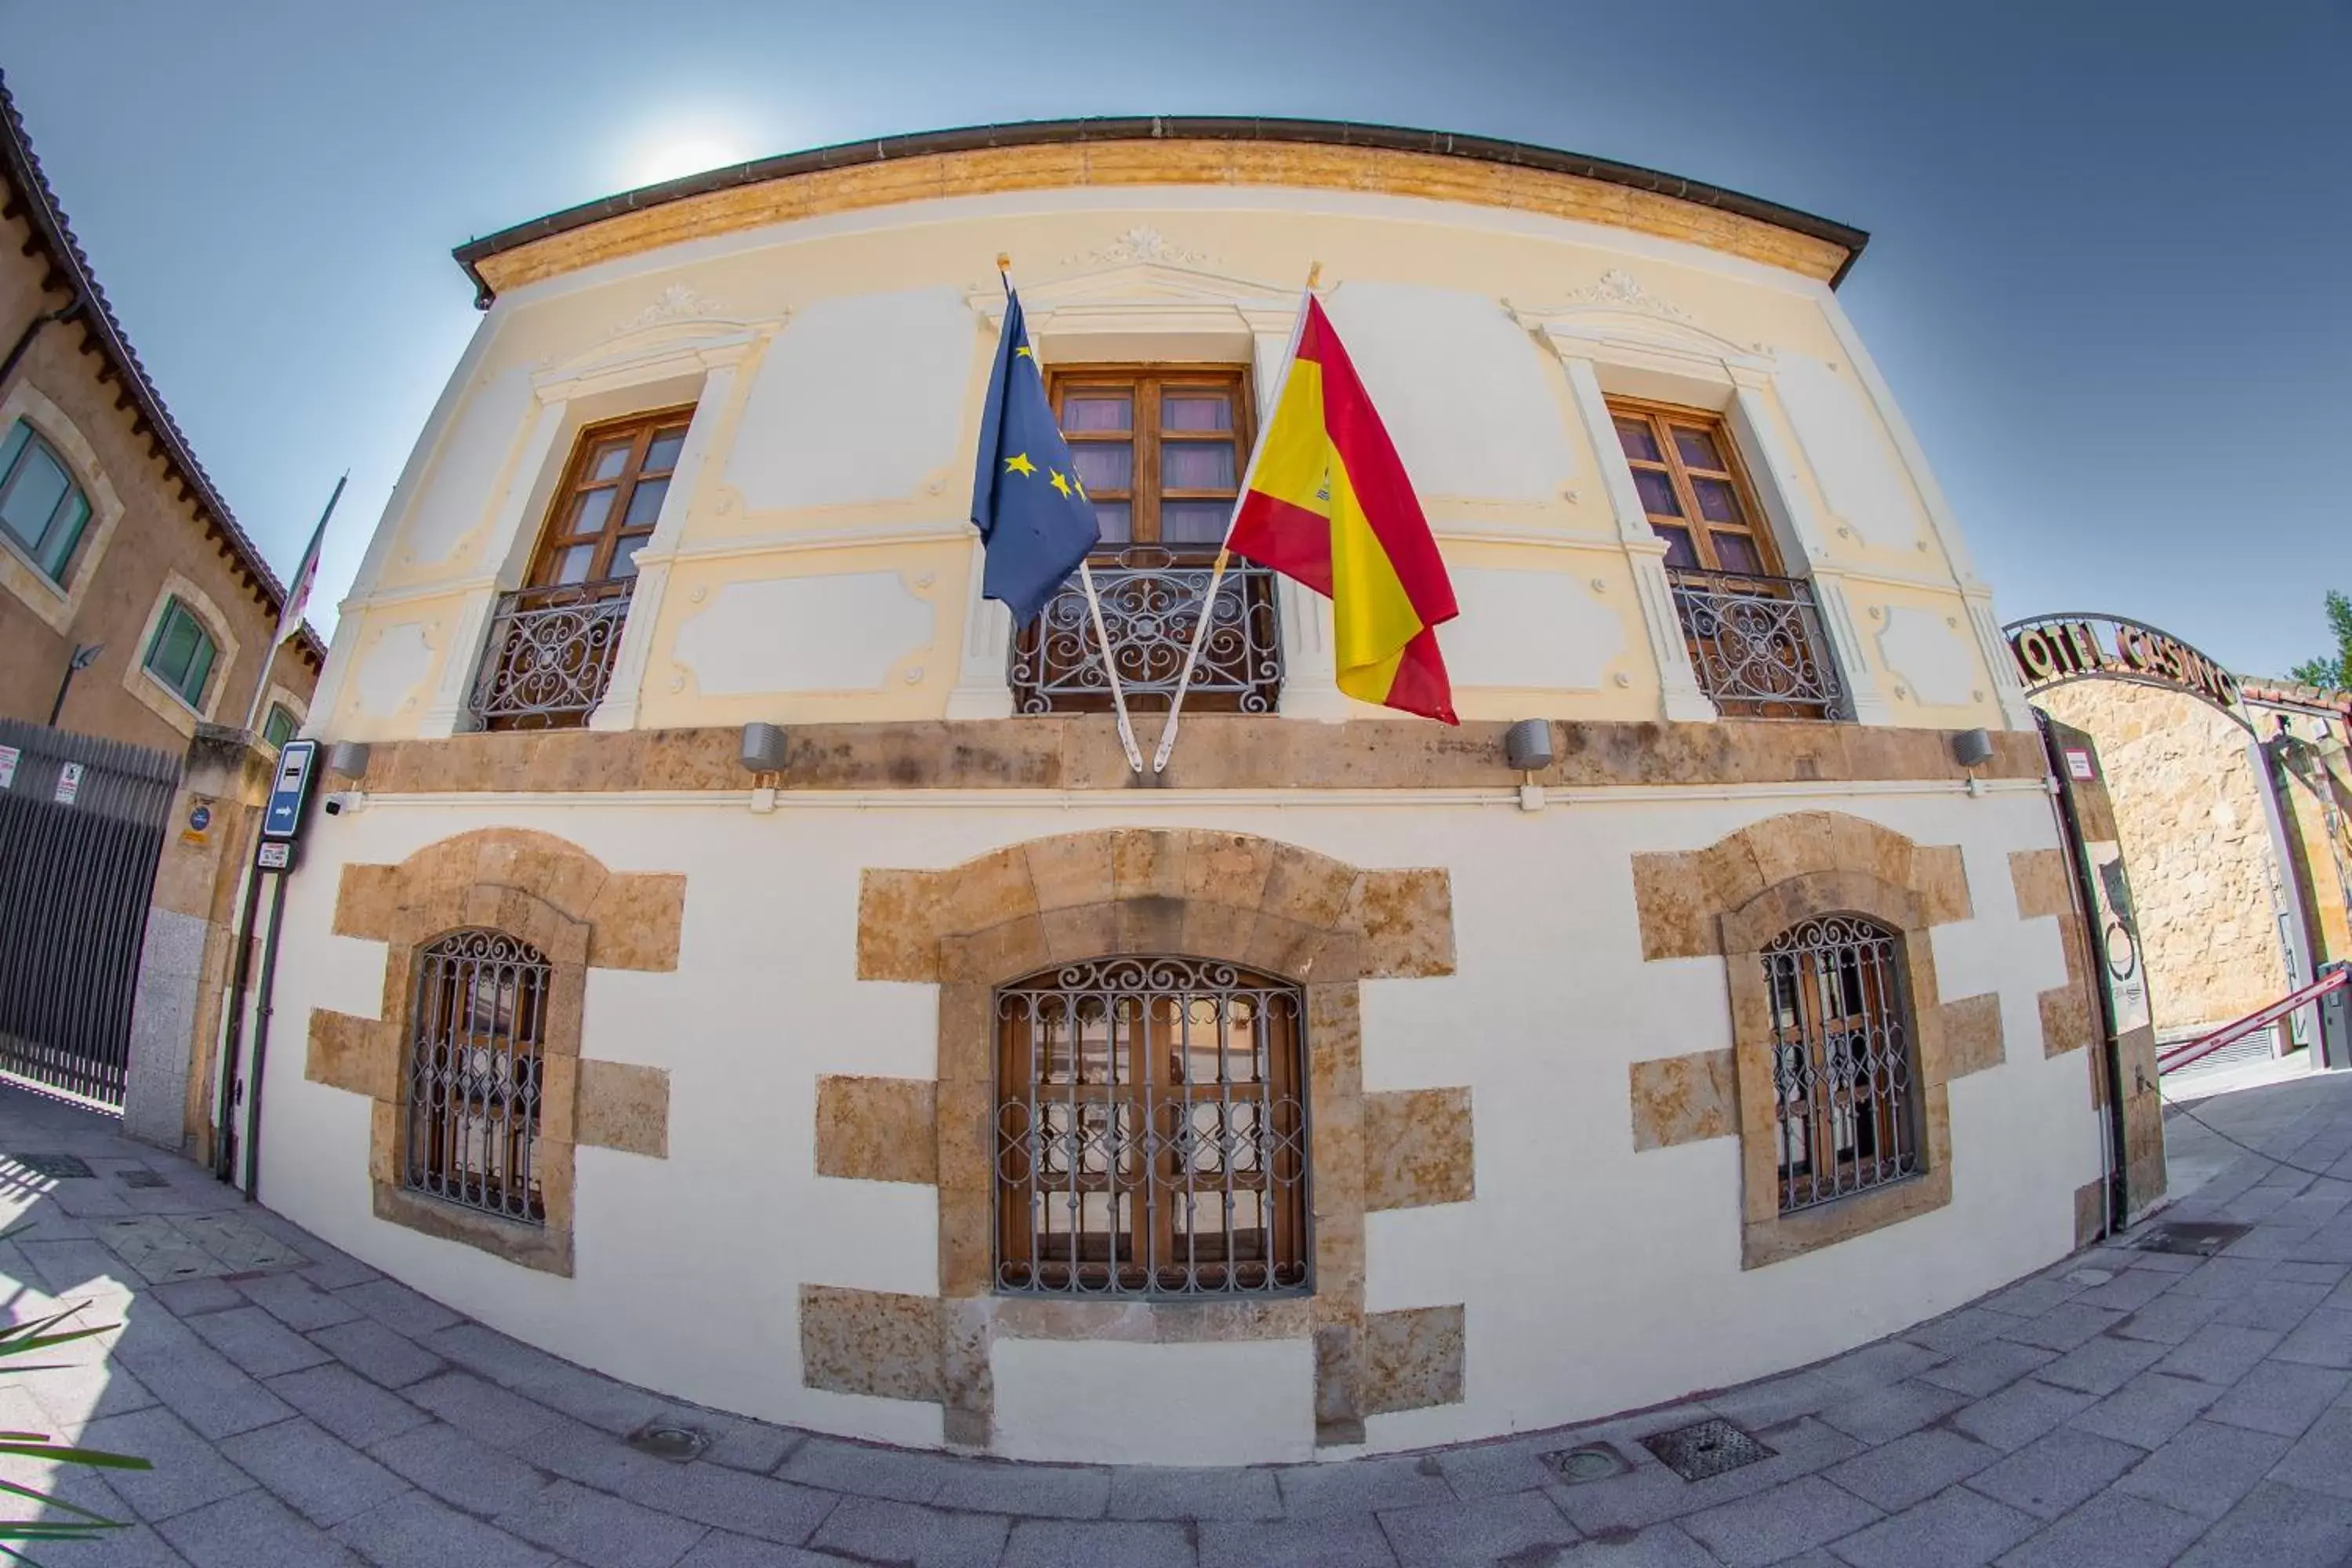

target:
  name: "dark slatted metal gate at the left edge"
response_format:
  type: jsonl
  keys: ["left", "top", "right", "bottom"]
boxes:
{"left": 0, "top": 720, "right": 181, "bottom": 1105}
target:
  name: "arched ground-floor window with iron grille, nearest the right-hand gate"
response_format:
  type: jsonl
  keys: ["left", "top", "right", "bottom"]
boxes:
{"left": 1764, "top": 914, "right": 1924, "bottom": 1213}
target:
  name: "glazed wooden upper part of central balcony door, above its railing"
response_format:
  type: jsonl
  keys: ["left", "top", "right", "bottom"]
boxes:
{"left": 1054, "top": 365, "right": 1249, "bottom": 553}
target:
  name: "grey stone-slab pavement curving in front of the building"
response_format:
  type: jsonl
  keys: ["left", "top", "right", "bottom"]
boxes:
{"left": 0, "top": 1076, "right": 2352, "bottom": 1568}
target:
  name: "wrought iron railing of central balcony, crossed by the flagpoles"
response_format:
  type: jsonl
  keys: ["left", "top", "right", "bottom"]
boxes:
{"left": 1011, "top": 546, "right": 1282, "bottom": 713}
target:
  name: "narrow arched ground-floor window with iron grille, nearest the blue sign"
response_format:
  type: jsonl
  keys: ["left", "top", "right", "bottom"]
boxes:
{"left": 402, "top": 928, "right": 553, "bottom": 1225}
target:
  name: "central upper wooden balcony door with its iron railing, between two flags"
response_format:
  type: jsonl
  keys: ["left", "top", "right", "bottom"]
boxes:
{"left": 1011, "top": 365, "right": 1282, "bottom": 713}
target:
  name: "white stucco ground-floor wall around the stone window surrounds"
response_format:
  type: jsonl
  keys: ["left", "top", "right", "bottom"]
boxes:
{"left": 261, "top": 787, "right": 2100, "bottom": 1460}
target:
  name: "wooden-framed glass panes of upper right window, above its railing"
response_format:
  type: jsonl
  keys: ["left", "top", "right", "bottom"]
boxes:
{"left": 1609, "top": 397, "right": 1780, "bottom": 576}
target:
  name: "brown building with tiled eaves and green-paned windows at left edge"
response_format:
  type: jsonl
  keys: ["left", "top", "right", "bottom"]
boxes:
{"left": 0, "top": 73, "right": 327, "bottom": 1147}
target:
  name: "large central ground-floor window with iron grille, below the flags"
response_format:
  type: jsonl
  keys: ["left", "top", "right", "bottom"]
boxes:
{"left": 995, "top": 956, "right": 1310, "bottom": 1298}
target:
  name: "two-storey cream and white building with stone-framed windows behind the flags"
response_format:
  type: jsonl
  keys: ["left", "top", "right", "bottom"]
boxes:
{"left": 261, "top": 120, "right": 2117, "bottom": 1462}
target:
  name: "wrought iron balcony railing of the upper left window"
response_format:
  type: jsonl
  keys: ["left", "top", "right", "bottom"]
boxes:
{"left": 473, "top": 579, "right": 635, "bottom": 729}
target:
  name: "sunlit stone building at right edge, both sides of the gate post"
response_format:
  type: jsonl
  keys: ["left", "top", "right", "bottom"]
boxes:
{"left": 2032, "top": 680, "right": 2352, "bottom": 1048}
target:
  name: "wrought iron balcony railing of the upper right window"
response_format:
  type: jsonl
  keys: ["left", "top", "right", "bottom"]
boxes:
{"left": 1665, "top": 567, "right": 1851, "bottom": 720}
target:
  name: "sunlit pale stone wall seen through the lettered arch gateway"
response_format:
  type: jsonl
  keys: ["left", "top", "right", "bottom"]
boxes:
{"left": 2034, "top": 682, "right": 2286, "bottom": 1039}
